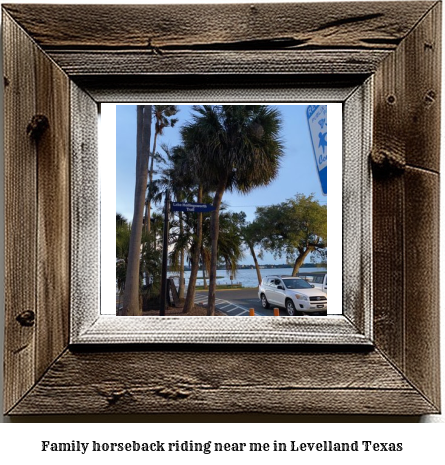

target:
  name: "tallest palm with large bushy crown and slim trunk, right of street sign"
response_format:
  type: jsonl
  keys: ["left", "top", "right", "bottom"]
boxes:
{"left": 186, "top": 105, "right": 283, "bottom": 315}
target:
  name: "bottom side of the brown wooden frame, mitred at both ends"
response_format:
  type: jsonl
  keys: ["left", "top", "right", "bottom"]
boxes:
{"left": 6, "top": 349, "right": 435, "bottom": 415}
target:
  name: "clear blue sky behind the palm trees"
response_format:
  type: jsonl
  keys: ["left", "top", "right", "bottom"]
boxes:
{"left": 116, "top": 104, "right": 327, "bottom": 264}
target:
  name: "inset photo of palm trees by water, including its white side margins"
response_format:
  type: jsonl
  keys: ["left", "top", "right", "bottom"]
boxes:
{"left": 109, "top": 103, "right": 338, "bottom": 317}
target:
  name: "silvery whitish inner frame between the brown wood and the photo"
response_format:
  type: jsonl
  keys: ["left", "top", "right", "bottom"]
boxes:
{"left": 70, "top": 78, "right": 373, "bottom": 345}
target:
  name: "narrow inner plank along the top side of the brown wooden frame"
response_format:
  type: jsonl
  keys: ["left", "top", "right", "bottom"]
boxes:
{"left": 48, "top": 50, "right": 390, "bottom": 78}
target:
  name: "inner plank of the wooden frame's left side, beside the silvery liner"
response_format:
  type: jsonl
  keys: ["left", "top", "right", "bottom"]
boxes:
{"left": 35, "top": 39, "right": 71, "bottom": 378}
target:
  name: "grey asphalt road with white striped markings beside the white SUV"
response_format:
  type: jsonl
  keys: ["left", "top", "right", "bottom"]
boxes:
{"left": 195, "top": 289, "right": 287, "bottom": 316}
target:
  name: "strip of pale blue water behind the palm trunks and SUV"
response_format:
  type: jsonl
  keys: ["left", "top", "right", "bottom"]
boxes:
{"left": 177, "top": 267, "right": 326, "bottom": 287}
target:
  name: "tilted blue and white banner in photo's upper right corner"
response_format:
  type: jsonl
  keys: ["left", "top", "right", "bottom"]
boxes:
{"left": 306, "top": 105, "right": 328, "bottom": 195}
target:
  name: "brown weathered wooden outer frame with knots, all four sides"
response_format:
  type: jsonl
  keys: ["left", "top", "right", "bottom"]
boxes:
{"left": 3, "top": 2, "right": 441, "bottom": 415}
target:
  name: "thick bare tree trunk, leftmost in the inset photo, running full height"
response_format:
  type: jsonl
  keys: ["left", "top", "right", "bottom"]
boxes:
{"left": 123, "top": 105, "right": 151, "bottom": 316}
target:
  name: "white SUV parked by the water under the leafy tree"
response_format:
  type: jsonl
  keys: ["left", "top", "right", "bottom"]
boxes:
{"left": 258, "top": 276, "right": 328, "bottom": 316}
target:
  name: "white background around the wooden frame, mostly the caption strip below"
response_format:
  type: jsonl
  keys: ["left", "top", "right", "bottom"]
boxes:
{"left": 0, "top": 0, "right": 445, "bottom": 464}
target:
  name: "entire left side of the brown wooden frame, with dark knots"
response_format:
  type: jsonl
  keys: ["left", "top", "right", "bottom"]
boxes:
{"left": 4, "top": 10, "right": 70, "bottom": 410}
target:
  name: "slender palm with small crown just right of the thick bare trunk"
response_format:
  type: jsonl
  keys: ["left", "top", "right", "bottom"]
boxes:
{"left": 145, "top": 105, "right": 179, "bottom": 232}
